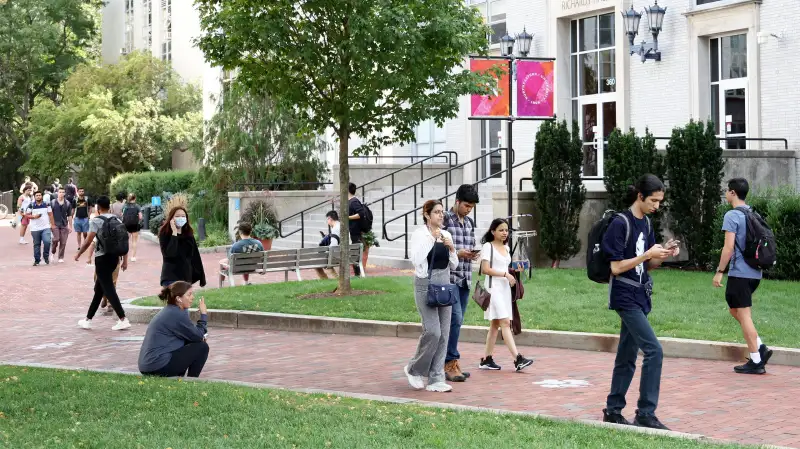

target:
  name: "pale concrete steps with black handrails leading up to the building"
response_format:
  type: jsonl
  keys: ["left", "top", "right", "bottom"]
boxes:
{"left": 273, "top": 185, "right": 505, "bottom": 268}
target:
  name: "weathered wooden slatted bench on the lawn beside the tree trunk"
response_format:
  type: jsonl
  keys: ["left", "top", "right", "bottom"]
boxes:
{"left": 219, "top": 243, "right": 365, "bottom": 288}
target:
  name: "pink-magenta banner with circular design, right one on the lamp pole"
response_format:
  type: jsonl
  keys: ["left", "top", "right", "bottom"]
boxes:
{"left": 516, "top": 60, "right": 555, "bottom": 117}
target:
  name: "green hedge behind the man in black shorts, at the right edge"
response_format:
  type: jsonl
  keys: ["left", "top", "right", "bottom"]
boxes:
{"left": 714, "top": 187, "right": 800, "bottom": 281}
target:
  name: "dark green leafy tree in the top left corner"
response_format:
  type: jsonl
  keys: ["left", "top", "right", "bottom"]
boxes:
{"left": 0, "top": 0, "right": 103, "bottom": 187}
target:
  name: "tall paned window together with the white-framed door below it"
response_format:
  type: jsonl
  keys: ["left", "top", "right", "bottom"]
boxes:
{"left": 570, "top": 13, "right": 617, "bottom": 177}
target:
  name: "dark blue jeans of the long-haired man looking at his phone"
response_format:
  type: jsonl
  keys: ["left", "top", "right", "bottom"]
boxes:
{"left": 606, "top": 310, "right": 664, "bottom": 416}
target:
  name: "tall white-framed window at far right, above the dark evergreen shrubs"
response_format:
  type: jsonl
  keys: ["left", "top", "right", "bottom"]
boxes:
{"left": 709, "top": 34, "right": 747, "bottom": 149}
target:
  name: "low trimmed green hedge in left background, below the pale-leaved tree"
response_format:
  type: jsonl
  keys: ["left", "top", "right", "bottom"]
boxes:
{"left": 109, "top": 170, "right": 197, "bottom": 204}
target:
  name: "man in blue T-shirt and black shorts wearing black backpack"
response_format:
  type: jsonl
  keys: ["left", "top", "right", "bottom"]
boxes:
{"left": 713, "top": 178, "right": 775, "bottom": 374}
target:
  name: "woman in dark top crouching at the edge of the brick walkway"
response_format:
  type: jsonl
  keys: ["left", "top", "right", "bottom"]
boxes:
{"left": 139, "top": 281, "right": 208, "bottom": 377}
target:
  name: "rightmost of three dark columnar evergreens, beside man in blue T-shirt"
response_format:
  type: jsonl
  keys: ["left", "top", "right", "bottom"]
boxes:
{"left": 666, "top": 120, "right": 725, "bottom": 268}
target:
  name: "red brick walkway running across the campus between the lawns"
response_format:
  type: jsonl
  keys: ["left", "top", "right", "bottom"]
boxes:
{"left": 0, "top": 222, "right": 800, "bottom": 448}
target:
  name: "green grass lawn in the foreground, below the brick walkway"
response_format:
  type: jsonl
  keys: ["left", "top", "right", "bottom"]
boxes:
{"left": 0, "top": 366, "right": 734, "bottom": 449}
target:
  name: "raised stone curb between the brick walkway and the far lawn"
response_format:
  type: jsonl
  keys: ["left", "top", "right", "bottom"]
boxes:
{"left": 120, "top": 299, "right": 800, "bottom": 366}
